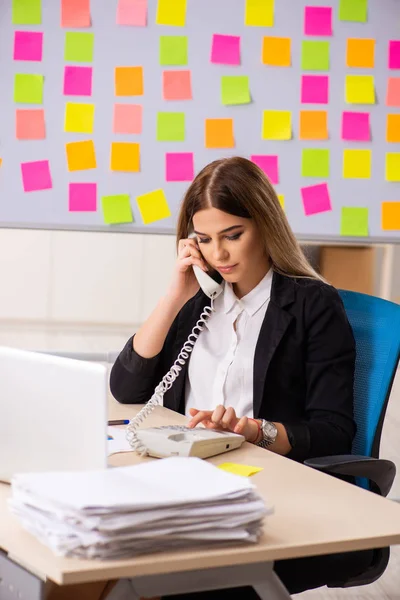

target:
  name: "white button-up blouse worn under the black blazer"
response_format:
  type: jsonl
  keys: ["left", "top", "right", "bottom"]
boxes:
{"left": 185, "top": 269, "right": 272, "bottom": 417}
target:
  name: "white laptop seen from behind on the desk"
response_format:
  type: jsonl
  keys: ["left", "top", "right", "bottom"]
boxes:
{"left": 0, "top": 347, "right": 108, "bottom": 482}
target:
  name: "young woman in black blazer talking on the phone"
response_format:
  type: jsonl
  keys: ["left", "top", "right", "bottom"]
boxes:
{"left": 110, "top": 157, "right": 372, "bottom": 600}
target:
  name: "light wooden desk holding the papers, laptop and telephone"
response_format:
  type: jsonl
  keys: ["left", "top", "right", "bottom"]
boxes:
{"left": 0, "top": 400, "right": 400, "bottom": 598}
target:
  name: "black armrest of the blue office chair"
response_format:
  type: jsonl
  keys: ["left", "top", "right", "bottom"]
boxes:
{"left": 304, "top": 454, "right": 396, "bottom": 496}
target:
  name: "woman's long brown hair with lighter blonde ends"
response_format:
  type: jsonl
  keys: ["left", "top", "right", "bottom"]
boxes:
{"left": 177, "top": 156, "right": 323, "bottom": 280}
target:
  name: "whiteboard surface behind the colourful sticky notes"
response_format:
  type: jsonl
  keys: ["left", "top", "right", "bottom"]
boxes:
{"left": 0, "top": 0, "right": 400, "bottom": 243}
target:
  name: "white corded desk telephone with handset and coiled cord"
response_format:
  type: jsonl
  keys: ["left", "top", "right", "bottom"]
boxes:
{"left": 126, "top": 234, "right": 245, "bottom": 458}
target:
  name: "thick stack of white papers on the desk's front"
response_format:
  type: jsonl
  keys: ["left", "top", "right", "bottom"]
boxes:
{"left": 10, "top": 458, "right": 272, "bottom": 559}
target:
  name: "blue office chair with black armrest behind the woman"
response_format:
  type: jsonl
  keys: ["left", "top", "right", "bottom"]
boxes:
{"left": 305, "top": 290, "right": 400, "bottom": 587}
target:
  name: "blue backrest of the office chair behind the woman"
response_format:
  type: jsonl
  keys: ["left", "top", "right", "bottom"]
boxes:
{"left": 339, "top": 290, "right": 400, "bottom": 458}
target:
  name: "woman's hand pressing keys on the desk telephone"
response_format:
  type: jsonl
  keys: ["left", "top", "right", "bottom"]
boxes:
{"left": 188, "top": 404, "right": 259, "bottom": 443}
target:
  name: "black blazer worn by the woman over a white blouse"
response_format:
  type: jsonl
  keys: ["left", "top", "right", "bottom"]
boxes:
{"left": 110, "top": 273, "right": 356, "bottom": 461}
